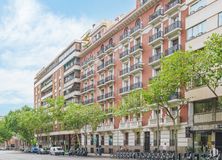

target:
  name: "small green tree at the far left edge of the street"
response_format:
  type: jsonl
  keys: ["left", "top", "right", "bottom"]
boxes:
{"left": 0, "top": 119, "right": 12, "bottom": 145}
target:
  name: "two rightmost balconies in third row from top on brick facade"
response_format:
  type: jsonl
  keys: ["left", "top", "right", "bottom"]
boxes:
{"left": 149, "top": 44, "right": 182, "bottom": 65}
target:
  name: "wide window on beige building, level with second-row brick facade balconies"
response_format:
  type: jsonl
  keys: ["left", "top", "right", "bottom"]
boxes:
{"left": 187, "top": 21, "right": 205, "bottom": 40}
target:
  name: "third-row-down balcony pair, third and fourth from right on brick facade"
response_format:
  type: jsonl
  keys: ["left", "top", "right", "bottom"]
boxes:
{"left": 120, "top": 62, "right": 143, "bottom": 77}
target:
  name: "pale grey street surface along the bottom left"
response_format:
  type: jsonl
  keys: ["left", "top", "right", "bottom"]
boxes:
{"left": 0, "top": 151, "right": 113, "bottom": 160}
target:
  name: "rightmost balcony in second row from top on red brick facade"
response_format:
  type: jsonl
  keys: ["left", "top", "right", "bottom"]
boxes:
{"left": 165, "top": 21, "right": 182, "bottom": 37}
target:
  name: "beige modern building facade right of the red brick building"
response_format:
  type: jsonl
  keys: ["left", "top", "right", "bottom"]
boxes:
{"left": 185, "top": 0, "right": 222, "bottom": 151}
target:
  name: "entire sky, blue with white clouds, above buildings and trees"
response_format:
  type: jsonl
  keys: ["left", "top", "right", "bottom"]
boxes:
{"left": 0, "top": 0, "right": 135, "bottom": 116}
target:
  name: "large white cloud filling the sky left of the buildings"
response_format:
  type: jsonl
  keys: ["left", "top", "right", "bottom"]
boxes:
{"left": 0, "top": 0, "right": 93, "bottom": 107}
